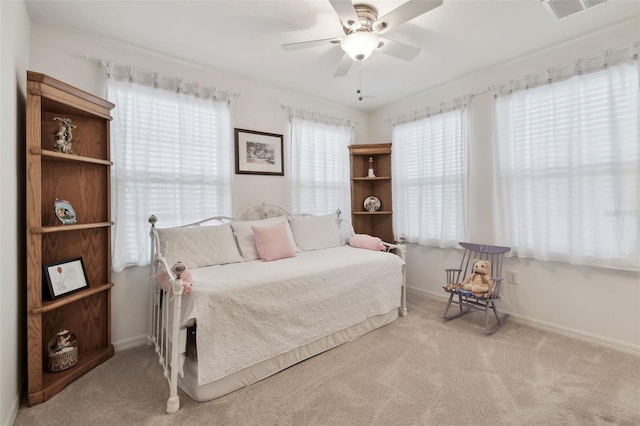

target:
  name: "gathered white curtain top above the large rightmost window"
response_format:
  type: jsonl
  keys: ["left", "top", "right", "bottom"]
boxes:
{"left": 491, "top": 41, "right": 640, "bottom": 97}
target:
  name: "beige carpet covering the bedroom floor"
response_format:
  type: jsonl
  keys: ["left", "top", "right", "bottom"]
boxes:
{"left": 15, "top": 293, "right": 640, "bottom": 426}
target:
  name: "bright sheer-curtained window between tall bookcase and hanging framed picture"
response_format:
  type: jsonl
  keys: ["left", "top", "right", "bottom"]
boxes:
{"left": 107, "top": 78, "right": 232, "bottom": 272}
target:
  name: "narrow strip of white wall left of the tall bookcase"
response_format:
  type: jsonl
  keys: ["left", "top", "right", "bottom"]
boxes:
{"left": 0, "top": 1, "right": 30, "bottom": 426}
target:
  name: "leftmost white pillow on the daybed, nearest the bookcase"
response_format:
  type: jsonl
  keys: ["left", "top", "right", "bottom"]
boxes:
{"left": 158, "top": 223, "right": 242, "bottom": 268}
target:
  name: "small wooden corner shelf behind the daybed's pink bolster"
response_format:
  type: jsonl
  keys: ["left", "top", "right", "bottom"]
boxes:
{"left": 349, "top": 143, "right": 395, "bottom": 242}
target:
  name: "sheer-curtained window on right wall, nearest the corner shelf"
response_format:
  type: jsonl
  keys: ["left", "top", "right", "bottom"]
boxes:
{"left": 392, "top": 107, "right": 467, "bottom": 247}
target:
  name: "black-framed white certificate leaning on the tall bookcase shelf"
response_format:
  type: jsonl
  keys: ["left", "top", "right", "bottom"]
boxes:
{"left": 42, "top": 257, "right": 89, "bottom": 300}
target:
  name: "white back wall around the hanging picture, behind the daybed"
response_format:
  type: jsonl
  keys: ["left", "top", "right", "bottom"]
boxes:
{"left": 30, "top": 23, "right": 369, "bottom": 349}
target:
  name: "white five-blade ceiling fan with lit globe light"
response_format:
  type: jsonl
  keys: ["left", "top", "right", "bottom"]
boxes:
{"left": 282, "top": 0, "right": 443, "bottom": 77}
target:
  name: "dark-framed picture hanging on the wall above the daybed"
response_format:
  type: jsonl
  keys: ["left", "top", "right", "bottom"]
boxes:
{"left": 234, "top": 129, "right": 284, "bottom": 176}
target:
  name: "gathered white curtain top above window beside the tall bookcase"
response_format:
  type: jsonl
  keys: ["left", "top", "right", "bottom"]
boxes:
{"left": 87, "top": 56, "right": 240, "bottom": 101}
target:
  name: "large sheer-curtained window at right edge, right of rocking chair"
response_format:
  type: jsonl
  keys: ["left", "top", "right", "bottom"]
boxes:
{"left": 496, "top": 60, "right": 640, "bottom": 270}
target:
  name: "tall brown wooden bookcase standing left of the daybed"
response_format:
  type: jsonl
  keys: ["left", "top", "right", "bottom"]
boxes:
{"left": 26, "top": 71, "right": 114, "bottom": 405}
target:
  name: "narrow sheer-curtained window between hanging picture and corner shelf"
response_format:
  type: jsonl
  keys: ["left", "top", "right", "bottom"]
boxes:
{"left": 289, "top": 116, "right": 353, "bottom": 218}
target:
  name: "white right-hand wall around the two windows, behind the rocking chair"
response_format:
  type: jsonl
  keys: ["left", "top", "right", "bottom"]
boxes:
{"left": 369, "top": 18, "right": 640, "bottom": 352}
